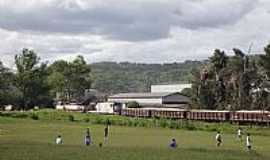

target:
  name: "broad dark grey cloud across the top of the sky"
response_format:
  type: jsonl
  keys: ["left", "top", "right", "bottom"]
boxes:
{"left": 0, "top": 0, "right": 257, "bottom": 41}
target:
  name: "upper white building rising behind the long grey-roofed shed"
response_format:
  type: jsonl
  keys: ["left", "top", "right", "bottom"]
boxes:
{"left": 151, "top": 84, "right": 191, "bottom": 93}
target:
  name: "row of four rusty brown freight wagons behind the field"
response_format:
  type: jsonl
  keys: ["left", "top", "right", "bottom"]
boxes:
{"left": 121, "top": 108, "right": 270, "bottom": 124}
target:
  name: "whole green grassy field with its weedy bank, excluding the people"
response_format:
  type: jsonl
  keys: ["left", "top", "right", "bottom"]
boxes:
{"left": 0, "top": 110, "right": 270, "bottom": 160}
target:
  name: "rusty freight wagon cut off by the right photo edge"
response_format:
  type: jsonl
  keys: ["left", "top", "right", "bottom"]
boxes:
{"left": 230, "top": 110, "right": 270, "bottom": 123}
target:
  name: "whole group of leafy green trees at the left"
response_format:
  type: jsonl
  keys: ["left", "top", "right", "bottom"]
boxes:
{"left": 0, "top": 49, "right": 91, "bottom": 109}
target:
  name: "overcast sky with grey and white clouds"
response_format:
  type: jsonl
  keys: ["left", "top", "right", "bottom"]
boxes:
{"left": 0, "top": 0, "right": 270, "bottom": 66}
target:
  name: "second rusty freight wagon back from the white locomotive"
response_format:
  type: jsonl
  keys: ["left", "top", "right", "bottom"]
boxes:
{"left": 151, "top": 108, "right": 187, "bottom": 119}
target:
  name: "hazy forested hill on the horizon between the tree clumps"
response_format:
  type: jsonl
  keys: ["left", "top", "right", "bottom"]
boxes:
{"left": 92, "top": 61, "right": 206, "bottom": 93}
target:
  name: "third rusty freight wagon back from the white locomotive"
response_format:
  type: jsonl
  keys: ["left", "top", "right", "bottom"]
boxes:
{"left": 187, "top": 110, "right": 230, "bottom": 121}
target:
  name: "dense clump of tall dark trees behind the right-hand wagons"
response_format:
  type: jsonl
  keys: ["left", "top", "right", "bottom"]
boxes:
{"left": 190, "top": 44, "right": 270, "bottom": 110}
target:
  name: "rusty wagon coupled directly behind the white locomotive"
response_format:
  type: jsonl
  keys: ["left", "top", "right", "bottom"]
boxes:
{"left": 122, "top": 108, "right": 151, "bottom": 117}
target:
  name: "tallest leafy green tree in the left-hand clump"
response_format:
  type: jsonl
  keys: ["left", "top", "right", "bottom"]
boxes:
{"left": 15, "top": 49, "right": 51, "bottom": 109}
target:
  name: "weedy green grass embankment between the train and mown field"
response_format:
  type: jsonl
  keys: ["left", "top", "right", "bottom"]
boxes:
{"left": 0, "top": 109, "right": 270, "bottom": 136}
